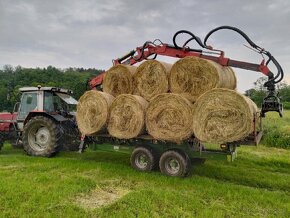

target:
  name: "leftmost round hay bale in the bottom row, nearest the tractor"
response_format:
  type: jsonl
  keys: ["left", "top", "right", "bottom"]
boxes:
{"left": 76, "top": 90, "right": 114, "bottom": 135}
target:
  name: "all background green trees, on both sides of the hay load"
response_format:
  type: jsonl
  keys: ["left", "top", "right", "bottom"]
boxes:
{"left": 0, "top": 65, "right": 290, "bottom": 111}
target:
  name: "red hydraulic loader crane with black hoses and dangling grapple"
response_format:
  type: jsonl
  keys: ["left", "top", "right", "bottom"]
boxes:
{"left": 89, "top": 26, "right": 284, "bottom": 117}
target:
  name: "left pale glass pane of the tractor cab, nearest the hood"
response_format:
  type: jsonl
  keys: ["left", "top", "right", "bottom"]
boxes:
{"left": 18, "top": 93, "right": 37, "bottom": 120}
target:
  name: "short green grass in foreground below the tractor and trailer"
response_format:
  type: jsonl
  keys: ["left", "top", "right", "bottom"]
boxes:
{"left": 0, "top": 144, "right": 290, "bottom": 217}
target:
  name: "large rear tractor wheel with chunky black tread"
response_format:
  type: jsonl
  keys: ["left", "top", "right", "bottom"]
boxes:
{"left": 22, "top": 116, "right": 62, "bottom": 157}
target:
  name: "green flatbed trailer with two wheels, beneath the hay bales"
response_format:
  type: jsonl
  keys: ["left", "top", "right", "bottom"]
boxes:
{"left": 80, "top": 113, "right": 263, "bottom": 177}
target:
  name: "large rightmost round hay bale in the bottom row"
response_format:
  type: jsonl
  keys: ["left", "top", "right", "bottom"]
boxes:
{"left": 192, "top": 88, "right": 258, "bottom": 144}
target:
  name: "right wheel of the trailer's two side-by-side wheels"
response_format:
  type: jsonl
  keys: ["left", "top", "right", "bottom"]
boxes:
{"left": 159, "top": 150, "right": 190, "bottom": 177}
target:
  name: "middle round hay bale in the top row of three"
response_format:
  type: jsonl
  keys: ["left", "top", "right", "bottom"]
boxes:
{"left": 133, "top": 60, "right": 172, "bottom": 101}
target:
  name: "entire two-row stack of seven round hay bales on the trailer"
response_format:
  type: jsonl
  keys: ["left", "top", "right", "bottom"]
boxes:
{"left": 77, "top": 57, "right": 257, "bottom": 143}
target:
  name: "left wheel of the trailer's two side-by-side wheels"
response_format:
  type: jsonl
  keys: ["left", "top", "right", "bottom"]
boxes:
{"left": 131, "top": 147, "right": 157, "bottom": 171}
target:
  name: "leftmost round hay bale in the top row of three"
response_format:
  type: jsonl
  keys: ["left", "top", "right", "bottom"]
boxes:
{"left": 103, "top": 65, "right": 136, "bottom": 97}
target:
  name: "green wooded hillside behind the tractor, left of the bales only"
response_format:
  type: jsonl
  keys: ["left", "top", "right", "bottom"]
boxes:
{"left": 0, "top": 65, "right": 102, "bottom": 111}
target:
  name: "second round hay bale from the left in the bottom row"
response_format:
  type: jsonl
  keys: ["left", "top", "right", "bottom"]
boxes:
{"left": 108, "top": 94, "right": 148, "bottom": 139}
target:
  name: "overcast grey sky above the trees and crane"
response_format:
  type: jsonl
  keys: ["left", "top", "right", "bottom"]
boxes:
{"left": 0, "top": 0, "right": 290, "bottom": 92}
